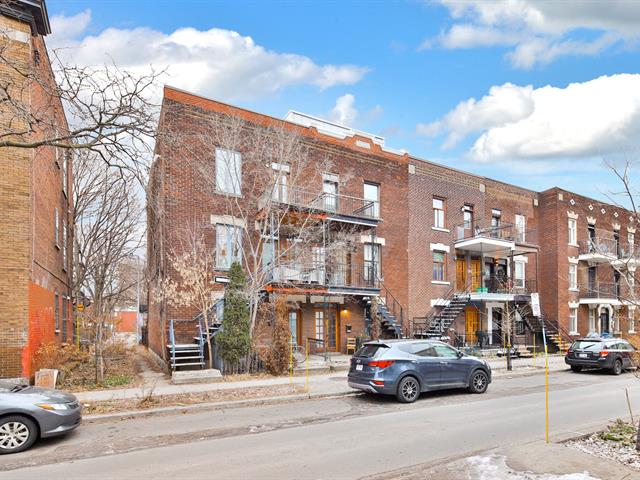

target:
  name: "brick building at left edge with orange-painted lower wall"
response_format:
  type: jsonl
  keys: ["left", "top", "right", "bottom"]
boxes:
{"left": 0, "top": 0, "right": 73, "bottom": 377}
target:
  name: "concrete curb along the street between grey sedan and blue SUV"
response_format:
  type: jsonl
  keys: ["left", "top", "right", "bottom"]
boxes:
{"left": 82, "top": 390, "right": 361, "bottom": 423}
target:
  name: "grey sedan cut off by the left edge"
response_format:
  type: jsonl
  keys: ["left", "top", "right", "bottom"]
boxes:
{"left": 0, "top": 382, "right": 82, "bottom": 455}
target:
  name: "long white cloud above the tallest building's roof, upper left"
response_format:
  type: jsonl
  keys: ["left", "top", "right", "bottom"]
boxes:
{"left": 48, "top": 10, "right": 368, "bottom": 100}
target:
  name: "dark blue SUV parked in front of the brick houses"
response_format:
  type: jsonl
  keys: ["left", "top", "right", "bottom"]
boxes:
{"left": 348, "top": 340, "right": 491, "bottom": 403}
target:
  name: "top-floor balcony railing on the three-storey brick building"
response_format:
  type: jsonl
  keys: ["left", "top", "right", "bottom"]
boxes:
{"left": 263, "top": 187, "right": 380, "bottom": 220}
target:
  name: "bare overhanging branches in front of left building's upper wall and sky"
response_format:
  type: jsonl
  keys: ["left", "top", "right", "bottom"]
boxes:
{"left": 0, "top": 20, "right": 163, "bottom": 178}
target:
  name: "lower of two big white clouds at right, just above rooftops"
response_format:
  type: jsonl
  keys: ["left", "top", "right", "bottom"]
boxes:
{"left": 418, "top": 74, "right": 640, "bottom": 162}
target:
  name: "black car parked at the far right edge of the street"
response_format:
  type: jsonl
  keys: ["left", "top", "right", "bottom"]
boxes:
{"left": 564, "top": 337, "right": 636, "bottom": 375}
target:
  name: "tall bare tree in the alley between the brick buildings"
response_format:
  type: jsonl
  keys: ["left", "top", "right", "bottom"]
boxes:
{"left": 72, "top": 151, "right": 143, "bottom": 382}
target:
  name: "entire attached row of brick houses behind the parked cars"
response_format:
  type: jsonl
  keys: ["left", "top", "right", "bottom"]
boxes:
{"left": 148, "top": 87, "right": 635, "bottom": 368}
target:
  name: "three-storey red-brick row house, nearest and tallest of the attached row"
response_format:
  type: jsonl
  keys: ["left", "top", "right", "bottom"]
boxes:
{"left": 148, "top": 87, "right": 408, "bottom": 364}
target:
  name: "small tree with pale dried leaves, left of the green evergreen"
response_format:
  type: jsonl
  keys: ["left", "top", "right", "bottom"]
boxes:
{"left": 154, "top": 224, "right": 221, "bottom": 368}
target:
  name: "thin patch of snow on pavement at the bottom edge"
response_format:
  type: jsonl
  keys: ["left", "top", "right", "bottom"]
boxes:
{"left": 467, "top": 455, "right": 602, "bottom": 480}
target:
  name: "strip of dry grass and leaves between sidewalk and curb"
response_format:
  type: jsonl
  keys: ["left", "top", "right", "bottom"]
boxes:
{"left": 83, "top": 385, "right": 304, "bottom": 415}
